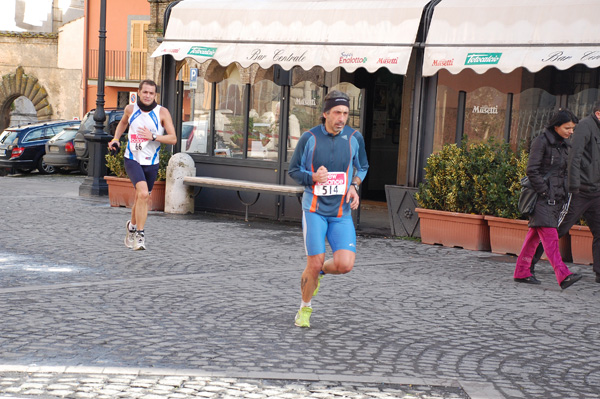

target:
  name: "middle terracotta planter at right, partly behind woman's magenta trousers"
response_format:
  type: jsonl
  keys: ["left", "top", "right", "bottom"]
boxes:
{"left": 485, "top": 215, "right": 571, "bottom": 262}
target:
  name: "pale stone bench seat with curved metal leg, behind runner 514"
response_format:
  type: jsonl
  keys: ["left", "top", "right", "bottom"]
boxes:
{"left": 183, "top": 176, "right": 304, "bottom": 222}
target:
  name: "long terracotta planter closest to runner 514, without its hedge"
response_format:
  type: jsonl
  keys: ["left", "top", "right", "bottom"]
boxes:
{"left": 415, "top": 208, "right": 490, "bottom": 251}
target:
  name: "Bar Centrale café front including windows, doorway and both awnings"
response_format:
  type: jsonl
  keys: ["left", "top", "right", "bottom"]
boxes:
{"left": 149, "top": 0, "right": 600, "bottom": 225}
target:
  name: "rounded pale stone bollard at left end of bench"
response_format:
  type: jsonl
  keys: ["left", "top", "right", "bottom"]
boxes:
{"left": 165, "top": 152, "right": 196, "bottom": 214}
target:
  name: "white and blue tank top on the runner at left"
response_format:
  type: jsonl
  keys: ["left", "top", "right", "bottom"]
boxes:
{"left": 125, "top": 104, "right": 165, "bottom": 165}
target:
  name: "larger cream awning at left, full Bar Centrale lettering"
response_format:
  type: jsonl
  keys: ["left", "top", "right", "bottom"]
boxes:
{"left": 152, "top": 0, "right": 428, "bottom": 75}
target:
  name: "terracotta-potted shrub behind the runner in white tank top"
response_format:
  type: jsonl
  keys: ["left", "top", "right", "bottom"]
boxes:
{"left": 104, "top": 144, "right": 171, "bottom": 211}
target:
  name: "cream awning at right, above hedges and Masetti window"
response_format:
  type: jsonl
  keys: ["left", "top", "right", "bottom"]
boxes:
{"left": 423, "top": 0, "right": 600, "bottom": 76}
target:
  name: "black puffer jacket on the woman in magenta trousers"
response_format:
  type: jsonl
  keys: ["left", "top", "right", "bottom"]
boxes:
{"left": 527, "top": 129, "right": 570, "bottom": 227}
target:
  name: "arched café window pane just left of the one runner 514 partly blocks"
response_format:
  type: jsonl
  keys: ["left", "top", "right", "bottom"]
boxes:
{"left": 247, "top": 80, "right": 281, "bottom": 161}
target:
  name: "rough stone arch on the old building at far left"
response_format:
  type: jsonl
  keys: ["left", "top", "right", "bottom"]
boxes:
{"left": 0, "top": 66, "right": 53, "bottom": 131}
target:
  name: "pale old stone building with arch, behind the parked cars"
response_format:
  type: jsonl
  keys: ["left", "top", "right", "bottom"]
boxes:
{"left": 0, "top": 0, "right": 83, "bottom": 131}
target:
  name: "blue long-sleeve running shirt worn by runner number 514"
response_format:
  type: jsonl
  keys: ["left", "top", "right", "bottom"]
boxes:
{"left": 288, "top": 125, "right": 369, "bottom": 217}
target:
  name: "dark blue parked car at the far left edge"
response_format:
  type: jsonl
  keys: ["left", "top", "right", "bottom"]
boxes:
{"left": 0, "top": 120, "right": 79, "bottom": 174}
